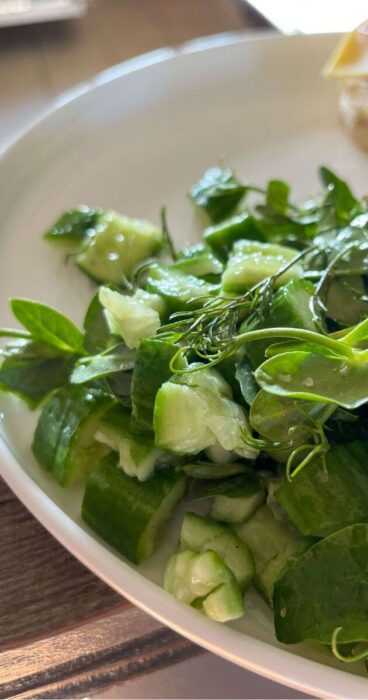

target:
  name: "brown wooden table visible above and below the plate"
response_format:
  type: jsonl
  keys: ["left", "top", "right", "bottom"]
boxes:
{"left": 0, "top": 0, "right": 268, "bottom": 698}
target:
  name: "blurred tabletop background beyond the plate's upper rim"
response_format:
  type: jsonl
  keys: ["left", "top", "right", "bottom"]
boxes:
{"left": 0, "top": 0, "right": 366, "bottom": 147}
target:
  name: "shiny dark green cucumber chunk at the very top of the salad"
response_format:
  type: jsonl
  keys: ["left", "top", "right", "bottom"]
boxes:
{"left": 189, "top": 168, "right": 247, "bottom": 223}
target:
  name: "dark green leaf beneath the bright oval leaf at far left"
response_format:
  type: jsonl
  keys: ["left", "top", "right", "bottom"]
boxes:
{"left": 0, "top": 342, "right": 75, "bottom": 408}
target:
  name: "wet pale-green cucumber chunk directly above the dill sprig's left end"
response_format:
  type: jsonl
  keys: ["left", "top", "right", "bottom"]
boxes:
{"left": 146, "top": 265, "right": 219, "bottom": 313}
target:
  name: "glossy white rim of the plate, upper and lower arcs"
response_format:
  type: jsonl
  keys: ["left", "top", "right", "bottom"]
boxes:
{"left": 0, "top": 30, "right": 368, "bottom": 699}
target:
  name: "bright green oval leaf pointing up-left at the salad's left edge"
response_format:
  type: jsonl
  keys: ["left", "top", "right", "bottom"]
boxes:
{"left": 10, "top": 299, "right": 84, "bottom": 354}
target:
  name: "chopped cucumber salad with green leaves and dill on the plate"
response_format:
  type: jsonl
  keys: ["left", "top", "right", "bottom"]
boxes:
{"left": 0, "top": 167, "right": 368, "bottom": 662}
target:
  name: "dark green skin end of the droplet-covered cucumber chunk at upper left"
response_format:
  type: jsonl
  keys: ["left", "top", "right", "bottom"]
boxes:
{"left": 44, "top": 206, "right": 100, "bottom": 249}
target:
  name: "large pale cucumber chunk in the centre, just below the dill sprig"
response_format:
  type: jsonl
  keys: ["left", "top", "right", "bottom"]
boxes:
{"left": 154, "top": 365, "right": 257, "bottom": 459}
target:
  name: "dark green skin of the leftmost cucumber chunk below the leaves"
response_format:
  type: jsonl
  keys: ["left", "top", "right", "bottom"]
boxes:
{"left": 32, "top": 387, "right": 111, "bottom": 486}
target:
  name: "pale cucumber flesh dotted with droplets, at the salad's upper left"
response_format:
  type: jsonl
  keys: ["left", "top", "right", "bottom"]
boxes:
{"left": 76, "top": 211, "right": 163, "bottom": 286}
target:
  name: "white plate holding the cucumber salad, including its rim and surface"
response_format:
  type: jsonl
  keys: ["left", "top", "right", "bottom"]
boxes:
{"left": 0, "top": 30, "right": 368, "bottom": 698}
